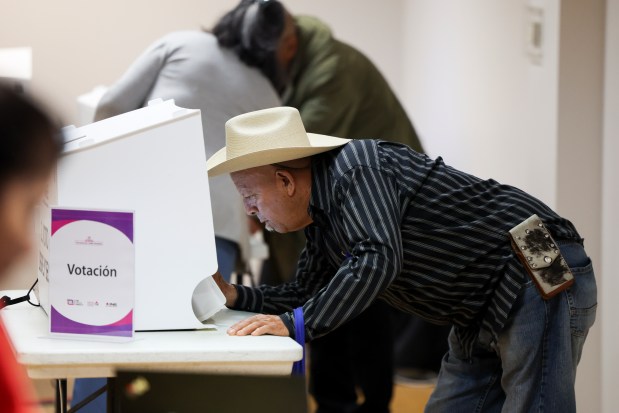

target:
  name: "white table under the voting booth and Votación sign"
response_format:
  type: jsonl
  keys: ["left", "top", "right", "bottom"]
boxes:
{"left": 0, "top": 290, "right": 303, "bottom": 410}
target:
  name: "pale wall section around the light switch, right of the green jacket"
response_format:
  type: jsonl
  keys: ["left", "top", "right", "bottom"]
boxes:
{"left": 403, "top": 0, "right": 559, "bottom": 206}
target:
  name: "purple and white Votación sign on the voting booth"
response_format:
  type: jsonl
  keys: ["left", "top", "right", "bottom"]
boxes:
{"left": 49, "top": 208, "right": 135, "bottom": 340}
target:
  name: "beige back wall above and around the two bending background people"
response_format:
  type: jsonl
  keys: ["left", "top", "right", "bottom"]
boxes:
{"left": 0, "top": 0, "right": 402, "bottom": 127}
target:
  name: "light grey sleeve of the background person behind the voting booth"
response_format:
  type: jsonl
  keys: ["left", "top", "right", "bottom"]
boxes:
{"left": 95, "top": 38, "right": 168, "bottom": 121}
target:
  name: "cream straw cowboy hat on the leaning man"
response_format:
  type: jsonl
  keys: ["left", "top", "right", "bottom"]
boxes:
{"left": 206, "top": 107, "right": 350, "bottom": 176}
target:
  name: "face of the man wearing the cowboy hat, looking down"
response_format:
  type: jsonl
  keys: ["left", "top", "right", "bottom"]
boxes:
{"left": 231, "top": 166, "right": 308, "bottom": 233}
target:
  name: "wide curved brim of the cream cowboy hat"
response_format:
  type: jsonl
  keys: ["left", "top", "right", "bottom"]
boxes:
{"left": 206, "top": 133, "right": 350, "bottom": 177}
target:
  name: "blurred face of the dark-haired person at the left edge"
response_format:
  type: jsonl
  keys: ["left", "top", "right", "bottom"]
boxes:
{"left": 0, "top": 178, "right": 47, "bottom": 275}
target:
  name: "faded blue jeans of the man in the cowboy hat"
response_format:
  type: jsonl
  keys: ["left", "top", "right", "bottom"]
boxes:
{"left": 425, "top": 242, "right": 597, "bottom": 413}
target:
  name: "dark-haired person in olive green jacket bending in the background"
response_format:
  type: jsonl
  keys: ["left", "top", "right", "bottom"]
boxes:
{"left": 213, "top": 0, "right": 447, "bottom": 413}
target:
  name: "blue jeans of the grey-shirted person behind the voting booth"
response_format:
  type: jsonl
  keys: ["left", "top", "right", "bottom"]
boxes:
{"left": 73, "top": 237, "right": 239, "bottom": 413}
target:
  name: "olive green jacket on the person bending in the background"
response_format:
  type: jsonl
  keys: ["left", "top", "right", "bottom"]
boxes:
{"left": 282, "top": 16, "right": 423, "bottom": 152}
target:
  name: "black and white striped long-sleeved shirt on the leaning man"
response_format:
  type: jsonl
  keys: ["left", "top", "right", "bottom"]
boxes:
{"left": 236, "top": 140, "right": 580, "bottom": 350}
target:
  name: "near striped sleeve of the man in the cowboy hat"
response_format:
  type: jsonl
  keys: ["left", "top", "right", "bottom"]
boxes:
{"left": 282, "top": 167, "right": 403, "bottom": 341}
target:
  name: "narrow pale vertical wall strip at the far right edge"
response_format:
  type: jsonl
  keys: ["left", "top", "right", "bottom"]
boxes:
{"left": 598, "top": 0, "right": 619, "bottom": 413}
